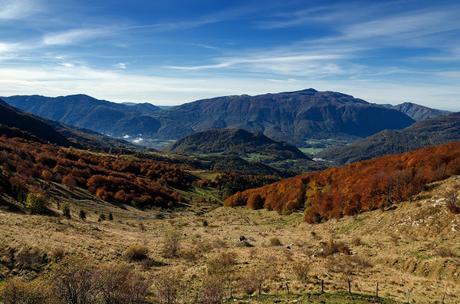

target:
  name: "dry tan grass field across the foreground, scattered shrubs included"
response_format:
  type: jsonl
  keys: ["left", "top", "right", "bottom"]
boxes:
{"left": 0, "top": 177, "right": 460, "bottom": 304}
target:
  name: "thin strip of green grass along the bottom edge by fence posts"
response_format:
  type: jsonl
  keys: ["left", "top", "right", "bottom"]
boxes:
{"left": 225, "top": 292, "right": 398, "bottom": 304}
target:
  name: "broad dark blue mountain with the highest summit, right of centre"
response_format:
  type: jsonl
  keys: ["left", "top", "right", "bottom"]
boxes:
{"left": 158, "top": 89, "right": 413, "bottom": 145}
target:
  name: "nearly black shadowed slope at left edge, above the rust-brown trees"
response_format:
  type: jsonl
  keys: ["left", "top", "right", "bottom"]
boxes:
{"left": 0, "top": 99, "right": 136, "bottom": 150}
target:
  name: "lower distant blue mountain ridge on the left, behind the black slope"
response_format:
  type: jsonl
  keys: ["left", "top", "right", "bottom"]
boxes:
{"left": 4, "top": 95, "right": 160, "bottom": 137}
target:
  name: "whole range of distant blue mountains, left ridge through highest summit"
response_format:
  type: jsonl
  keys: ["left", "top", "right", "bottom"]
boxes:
{"left": 6, "top": 89, "right": 414, "bottom": 146}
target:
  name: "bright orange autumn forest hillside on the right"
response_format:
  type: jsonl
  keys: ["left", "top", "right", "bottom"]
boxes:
{"left": 225, "top": 142, "right": 460, "bottom": 223}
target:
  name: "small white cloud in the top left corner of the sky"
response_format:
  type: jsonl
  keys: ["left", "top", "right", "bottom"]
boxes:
{"left": 0, "top": 0, "right": 41, "bottom": 20}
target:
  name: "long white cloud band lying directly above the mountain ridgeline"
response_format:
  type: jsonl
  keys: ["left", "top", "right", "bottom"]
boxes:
{"left": 0, "top": 66, "right": 460, "bottom": 110}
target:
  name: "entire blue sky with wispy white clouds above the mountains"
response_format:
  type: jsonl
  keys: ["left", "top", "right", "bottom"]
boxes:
{"left": 0, "top": 0, "right": 460, "bottom": 110}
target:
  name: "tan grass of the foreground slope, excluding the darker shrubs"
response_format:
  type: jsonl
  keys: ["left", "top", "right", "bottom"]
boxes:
{"left": 0, "top": 179, "right": 460, "bottom": 303}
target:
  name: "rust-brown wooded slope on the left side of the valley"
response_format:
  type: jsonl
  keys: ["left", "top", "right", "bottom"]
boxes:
{"left": 0, "top": 136, "right": 192, "bottom": 209}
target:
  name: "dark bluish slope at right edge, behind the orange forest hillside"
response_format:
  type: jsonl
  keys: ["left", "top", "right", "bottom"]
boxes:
{"left": 316, "top": 112, "right": 460, "bottom": 164}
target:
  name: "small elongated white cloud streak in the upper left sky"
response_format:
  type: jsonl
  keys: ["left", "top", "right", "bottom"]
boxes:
{"left": 42, "top": 28, "right": 113, "bottom": 46}
